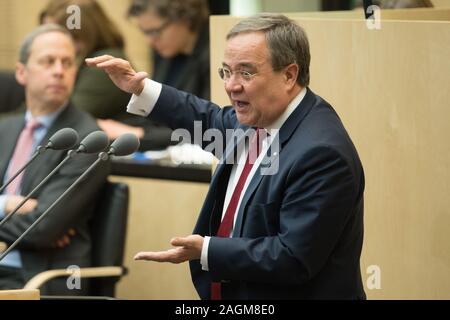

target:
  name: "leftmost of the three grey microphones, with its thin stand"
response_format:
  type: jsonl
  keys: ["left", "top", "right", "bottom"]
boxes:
{"left": 0, "top": 128, "right": 78, "bottom": 194}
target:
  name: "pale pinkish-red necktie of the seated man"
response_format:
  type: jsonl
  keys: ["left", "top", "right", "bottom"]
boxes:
{"left": 6, "top": 119, "right": 42, "bottom": 195}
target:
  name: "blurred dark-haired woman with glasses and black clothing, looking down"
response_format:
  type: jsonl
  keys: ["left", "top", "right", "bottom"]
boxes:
{"left": 98, "top": 0, "right": 210, "bottom": 149}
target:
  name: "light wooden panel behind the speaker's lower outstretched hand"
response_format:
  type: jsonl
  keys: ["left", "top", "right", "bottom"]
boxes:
{"left": 113, "top": 177, "right": 208, "bottom": 299}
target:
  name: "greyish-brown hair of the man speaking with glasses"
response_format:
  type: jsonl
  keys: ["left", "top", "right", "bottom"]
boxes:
{"left": 227, "top": 13, "right": 311, "bottom": 87}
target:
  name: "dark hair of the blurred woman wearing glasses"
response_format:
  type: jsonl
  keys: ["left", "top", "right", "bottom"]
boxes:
{"left": 128, "top": 0, "right": 209, "bottom": 32}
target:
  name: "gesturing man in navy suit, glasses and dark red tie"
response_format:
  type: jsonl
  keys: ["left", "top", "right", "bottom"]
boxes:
{"left": 87, "top": 14, "right": 365, "bottom": 299}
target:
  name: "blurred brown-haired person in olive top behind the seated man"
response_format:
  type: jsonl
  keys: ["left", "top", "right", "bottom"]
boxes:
{"left": 40, "top": 0, "right": 130, "bottom": 120}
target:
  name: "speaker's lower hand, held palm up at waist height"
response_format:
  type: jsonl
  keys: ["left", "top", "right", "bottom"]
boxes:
{"left": 134, "top": 235, "right": 203, "bottom": 263}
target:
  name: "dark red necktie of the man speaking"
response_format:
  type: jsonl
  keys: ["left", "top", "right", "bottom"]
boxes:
{"left": 211, "top": 129, "right": 262, "bottom": 300}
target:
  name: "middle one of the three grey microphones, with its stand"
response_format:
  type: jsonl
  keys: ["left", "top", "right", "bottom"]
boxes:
{"left": 0, "top": 131, "right": 109, "bottom": 227}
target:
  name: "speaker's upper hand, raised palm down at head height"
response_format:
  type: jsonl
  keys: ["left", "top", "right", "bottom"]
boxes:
{"left": 86, "top": 55, "right": 148, "bottom": 95}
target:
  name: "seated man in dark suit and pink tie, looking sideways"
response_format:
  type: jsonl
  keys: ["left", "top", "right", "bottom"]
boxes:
{"left": 0, "top": 25, "right": 108, "bottom": 295}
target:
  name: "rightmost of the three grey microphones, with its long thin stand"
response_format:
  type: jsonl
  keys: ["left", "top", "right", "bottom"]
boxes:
{"left": 0, "top": 133, "right": 139, "bottom": 261}
